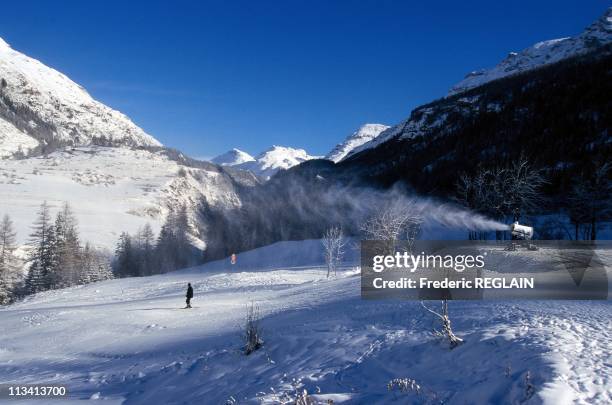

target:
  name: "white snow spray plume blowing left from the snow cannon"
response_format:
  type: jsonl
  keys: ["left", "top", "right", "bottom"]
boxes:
{"left": 200, "top": 177, "right": 508, "bottom": 258}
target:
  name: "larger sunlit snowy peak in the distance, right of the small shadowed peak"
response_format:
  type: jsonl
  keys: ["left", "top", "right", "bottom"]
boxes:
{"left": 235, "top": 145, "right": 318, "bottom": 180}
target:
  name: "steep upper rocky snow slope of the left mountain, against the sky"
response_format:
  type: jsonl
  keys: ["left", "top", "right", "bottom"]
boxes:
{"left": 0, "top": 39, "right": 161, "bottom": 157}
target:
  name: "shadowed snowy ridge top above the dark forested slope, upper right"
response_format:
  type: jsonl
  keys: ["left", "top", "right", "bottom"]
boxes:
{"left": 449, "top": 7, "right": 612, "bottom": 95}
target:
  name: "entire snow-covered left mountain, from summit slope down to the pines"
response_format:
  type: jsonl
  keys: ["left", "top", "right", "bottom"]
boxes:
{"left": 0, "top": 40, "right": 248, "bottom": 248}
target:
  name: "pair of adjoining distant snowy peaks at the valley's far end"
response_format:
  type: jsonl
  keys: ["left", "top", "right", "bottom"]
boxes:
{"left": 218, "top": 145, "right": 319, "bottom": 180}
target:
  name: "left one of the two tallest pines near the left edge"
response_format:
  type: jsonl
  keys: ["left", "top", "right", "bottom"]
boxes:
{"left": 26, "top": 201, "right": 54, "bottom": 294}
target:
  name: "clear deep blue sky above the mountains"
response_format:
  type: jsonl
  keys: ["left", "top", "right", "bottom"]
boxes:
{"left": 0, "top": 0, "right": 609, "bottom": 157}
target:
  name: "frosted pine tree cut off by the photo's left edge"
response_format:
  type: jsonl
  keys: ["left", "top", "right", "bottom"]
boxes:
{"left": 0, "top": 215, "right": 20, "bottom": 305}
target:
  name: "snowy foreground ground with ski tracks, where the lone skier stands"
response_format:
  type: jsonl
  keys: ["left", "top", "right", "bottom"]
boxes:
{"left": 0, "top": 241, "right": 612, "bottom": 404}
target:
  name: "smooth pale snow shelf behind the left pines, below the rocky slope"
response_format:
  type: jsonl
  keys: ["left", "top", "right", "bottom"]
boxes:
{"left": 0, "top": 147, "right": 240, "bottom": 248}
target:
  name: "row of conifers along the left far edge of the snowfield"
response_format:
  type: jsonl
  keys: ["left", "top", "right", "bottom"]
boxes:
{"left": 0, "top": 201, "right": 202, "bottom": 305}
